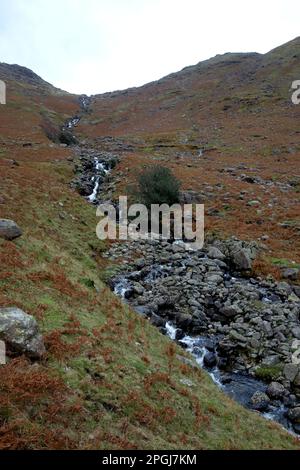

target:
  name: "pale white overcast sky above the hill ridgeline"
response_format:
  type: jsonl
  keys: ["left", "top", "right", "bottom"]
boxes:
{"left": 0, "top": 0, "right": 300, "bottom": 94}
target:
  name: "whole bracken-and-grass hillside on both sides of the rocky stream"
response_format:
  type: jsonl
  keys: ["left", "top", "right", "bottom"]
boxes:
{"left": 0, "top": 38, "right": 300, "bottom": 449}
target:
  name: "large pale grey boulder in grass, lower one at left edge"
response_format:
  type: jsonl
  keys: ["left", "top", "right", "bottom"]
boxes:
{"left": 0, "top": 307, "right": 45, "bottom": 359}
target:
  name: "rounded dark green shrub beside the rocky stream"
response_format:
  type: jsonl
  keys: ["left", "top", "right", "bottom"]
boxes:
{"left": 136, "top": 165, "right": 180, "bottom": 207}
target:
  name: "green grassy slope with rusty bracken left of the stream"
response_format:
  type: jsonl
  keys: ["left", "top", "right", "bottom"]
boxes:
{"left": 0, "top": 57, "right": 299, "bottom": 449}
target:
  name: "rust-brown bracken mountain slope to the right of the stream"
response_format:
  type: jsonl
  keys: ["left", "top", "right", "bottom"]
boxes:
{"left": 77, "top": 37, "right": 300, "bottom": 277}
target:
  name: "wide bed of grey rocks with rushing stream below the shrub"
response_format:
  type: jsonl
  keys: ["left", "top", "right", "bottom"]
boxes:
{"left": 102, "top": 239, "right": 300, "bottom": 433}
